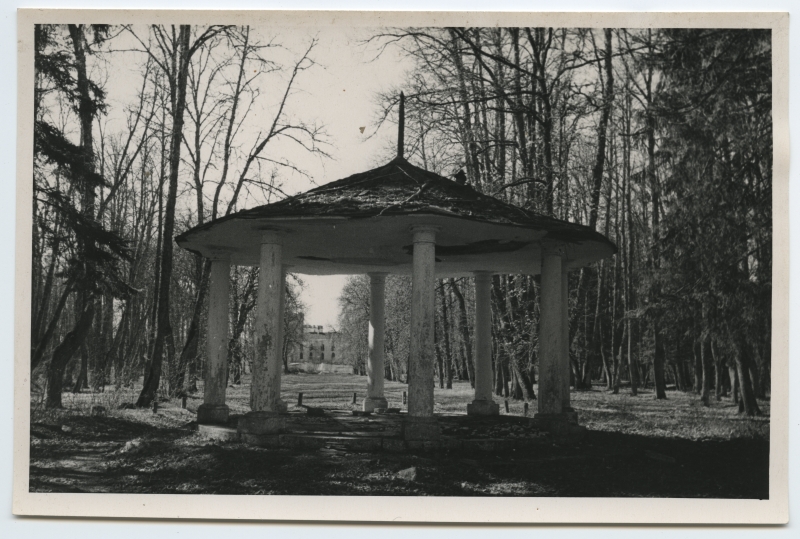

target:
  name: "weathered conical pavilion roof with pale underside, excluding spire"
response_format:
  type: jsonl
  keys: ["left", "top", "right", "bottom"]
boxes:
{"left": 176, "top": 157, "right": 616, "bottom": 275}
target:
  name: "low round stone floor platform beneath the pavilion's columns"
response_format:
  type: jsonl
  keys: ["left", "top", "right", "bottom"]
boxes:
{"left": 198, "top": 410, "right": 585, "bottom": 452}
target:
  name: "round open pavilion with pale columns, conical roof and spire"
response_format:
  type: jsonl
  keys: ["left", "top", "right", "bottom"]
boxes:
{"left": 176, "top": 100, "right": 616, "bottom": 440}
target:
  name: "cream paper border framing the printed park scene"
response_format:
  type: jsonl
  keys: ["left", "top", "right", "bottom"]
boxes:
{"left": 13, "top": 9, "right": 790, "bottom": 524}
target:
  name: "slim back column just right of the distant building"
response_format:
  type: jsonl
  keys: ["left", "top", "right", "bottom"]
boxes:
{"left": 363, "top": 273, "right": 389, "bottom": 412}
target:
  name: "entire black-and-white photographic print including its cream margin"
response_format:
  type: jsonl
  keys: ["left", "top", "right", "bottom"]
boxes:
{"left": 10, "top": 7, "right": 788, "bottom": 522}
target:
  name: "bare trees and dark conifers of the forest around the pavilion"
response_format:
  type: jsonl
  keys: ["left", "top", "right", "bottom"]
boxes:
{"left": 31, "top": 21, "right": 772, "bottom": 415}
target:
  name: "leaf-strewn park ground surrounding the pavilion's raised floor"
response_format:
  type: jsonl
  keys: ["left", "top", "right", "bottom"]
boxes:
{"left": 30, "top": 374, "right": 769, "bottom": 498}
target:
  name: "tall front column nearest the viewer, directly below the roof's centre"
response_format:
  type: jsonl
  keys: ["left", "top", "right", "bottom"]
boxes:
{"left": 403, "top": 226, "right": 439, "bottom": 440}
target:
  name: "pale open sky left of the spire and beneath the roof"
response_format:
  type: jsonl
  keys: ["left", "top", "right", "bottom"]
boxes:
{"left": 99, "top": 26, "right": 411, "bottom": 328}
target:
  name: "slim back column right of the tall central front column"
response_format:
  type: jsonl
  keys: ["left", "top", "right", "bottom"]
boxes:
{"left": 467, "top": 271, "right": 500, "bottom": 415}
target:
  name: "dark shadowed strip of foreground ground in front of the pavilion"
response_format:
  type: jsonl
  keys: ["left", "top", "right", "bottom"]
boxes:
{"left": 30, "top": 413, "right": 769, "bottom": 498}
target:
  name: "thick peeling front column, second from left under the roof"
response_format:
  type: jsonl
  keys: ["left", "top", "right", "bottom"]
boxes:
{"left": 239, "top": 231, "right": 284, "bottom": 434}
